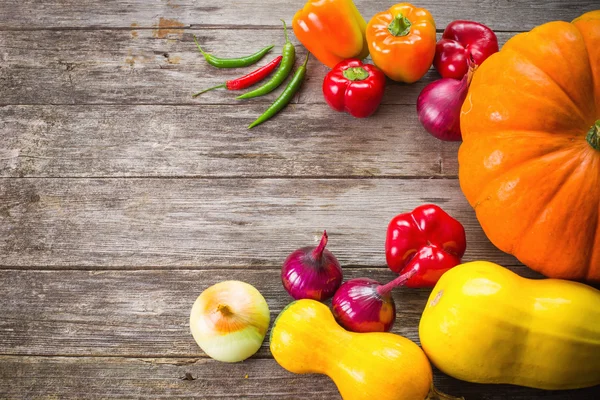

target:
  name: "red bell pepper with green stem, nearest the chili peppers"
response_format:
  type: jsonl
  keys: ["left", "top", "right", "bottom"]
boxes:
{"left": 323, "top": 58, "right": 385, "bottom": 118}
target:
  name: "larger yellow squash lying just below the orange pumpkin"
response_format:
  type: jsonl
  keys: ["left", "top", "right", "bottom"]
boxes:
{"left": 419, "top": 261, "right": 600, "bottom": 390}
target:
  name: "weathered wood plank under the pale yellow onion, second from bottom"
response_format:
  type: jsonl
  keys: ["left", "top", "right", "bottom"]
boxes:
{"left": 0, "top": 267, "right": 440, "bottom": 358}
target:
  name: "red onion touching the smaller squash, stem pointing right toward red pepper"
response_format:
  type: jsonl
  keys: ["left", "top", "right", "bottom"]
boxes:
{"left": 331, "top": 270, "right": 416, "bottom": 332}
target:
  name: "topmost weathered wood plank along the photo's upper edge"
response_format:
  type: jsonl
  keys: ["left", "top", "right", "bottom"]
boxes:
{"left": 0, "top": 0, "right": 597, "bottom": 31}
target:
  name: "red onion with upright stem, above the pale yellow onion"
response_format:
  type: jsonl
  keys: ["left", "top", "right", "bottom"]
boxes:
{"left": 281, "top": 231, "right": 342, "bottom": 301}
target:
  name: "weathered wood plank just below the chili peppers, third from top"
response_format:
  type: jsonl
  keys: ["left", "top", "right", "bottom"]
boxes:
{"left": 0, "top": 104, "right": 458, "bottom": 177}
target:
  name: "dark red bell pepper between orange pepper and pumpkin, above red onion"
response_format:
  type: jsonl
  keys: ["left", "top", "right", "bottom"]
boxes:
{"left": 433, "top": 20, "right": 498, "bottom": 79}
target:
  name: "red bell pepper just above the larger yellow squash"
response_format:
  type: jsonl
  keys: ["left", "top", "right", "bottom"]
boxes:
{"left": 385, "top": 204, "right": 467, "bottom": 288}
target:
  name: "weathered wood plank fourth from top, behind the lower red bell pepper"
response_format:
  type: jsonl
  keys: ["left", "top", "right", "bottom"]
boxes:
{"left": 0, "top": 178, "right": 515, "bottom": 268}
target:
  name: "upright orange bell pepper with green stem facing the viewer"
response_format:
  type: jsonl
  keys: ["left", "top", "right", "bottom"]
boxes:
{"left": 366, "top": 3, "right": 436, "bottom": 83}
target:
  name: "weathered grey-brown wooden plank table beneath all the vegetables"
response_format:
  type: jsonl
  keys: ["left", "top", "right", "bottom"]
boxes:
{"left": 0, "top": 0, "right": 600, "bottom": 400}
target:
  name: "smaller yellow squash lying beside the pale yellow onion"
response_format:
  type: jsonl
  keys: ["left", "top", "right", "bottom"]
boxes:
{"left": 271, "top": 299, "right": 433, "bottom": 400}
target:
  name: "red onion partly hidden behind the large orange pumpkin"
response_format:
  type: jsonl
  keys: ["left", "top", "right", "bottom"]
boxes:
{"left": 417, "top": 66, "right": 475, "bottom": 141}
